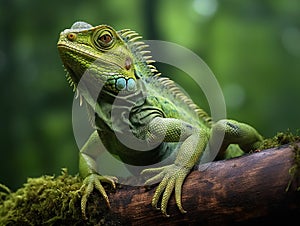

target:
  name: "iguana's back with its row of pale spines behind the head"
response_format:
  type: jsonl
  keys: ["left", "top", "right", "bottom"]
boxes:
{"left": 118, "top": 29, "right": 212, "bottom": 127}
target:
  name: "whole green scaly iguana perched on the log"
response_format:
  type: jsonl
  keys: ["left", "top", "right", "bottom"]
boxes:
{"left": 58, "top": 22, "right": 262, "bottom": 218}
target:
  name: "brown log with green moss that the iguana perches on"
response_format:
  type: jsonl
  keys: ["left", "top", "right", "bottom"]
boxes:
{"left": 0, "top": 144, "right": 300, "bottom": 226}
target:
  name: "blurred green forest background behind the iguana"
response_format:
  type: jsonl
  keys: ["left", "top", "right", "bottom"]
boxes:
{"left": 0, "top": 0, "right": 300, "bottom": 189}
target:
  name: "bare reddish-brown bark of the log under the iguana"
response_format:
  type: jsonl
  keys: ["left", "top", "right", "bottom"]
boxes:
{"left": 109, "top": 144, "right": 300, "bottom": 225}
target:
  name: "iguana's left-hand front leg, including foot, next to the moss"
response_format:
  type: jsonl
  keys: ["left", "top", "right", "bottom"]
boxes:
{"left": 79, "top": 131, "right": 117, "bottom": 219}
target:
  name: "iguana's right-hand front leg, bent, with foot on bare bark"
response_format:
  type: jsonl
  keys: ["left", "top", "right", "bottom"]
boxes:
{"left": 142, "top": 117, "right": 209, "bottom": 217}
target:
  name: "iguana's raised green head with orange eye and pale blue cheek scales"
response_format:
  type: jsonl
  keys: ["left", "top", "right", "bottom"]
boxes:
{"left": 57, "top": 22, "right": 137, "bottom": 93}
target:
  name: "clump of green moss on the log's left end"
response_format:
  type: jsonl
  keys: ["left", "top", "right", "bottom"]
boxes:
{"left": 0, "top": 169, "right": 120, "bottom": 225}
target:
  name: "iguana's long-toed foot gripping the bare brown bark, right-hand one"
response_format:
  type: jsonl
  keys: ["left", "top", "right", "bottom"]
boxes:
{"left": 141, "top": 164, "right": 190, "bottom": 217}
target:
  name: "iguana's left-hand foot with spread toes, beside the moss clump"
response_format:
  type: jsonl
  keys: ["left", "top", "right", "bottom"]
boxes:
{"left": 80, "top": 173, "right": 117, "bottom": 219}
